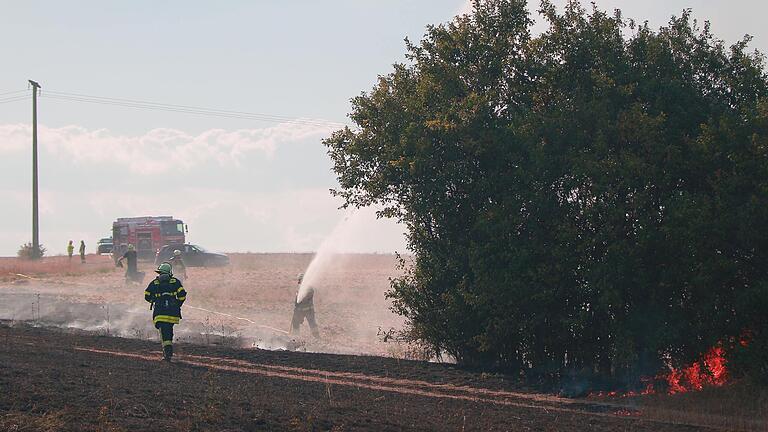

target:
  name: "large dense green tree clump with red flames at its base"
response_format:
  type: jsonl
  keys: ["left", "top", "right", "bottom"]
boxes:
{"left": 325, "top": 0, "right": 768, "bottom": 381}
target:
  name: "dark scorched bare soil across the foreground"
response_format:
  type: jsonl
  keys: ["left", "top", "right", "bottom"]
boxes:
{"left": 0, "top": 322, "right": 712, "bottom": 431}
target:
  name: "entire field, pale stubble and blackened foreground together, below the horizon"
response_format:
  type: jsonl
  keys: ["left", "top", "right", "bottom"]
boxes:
{"left": 0, "top": 254, "right": 768, "bottom": 431}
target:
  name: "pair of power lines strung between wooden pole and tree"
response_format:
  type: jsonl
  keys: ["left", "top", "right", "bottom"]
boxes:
{"left": 42, "top": 90, "right": 345, "bottom": 128}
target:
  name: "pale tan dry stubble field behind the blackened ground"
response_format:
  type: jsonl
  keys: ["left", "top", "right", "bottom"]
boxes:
{"left": 0, "top": 254, "right": 408, "bottom": 356}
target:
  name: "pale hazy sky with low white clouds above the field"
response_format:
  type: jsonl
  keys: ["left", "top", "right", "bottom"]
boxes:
{"left": 0, "top": 0, "right": 768, "bottom": 255}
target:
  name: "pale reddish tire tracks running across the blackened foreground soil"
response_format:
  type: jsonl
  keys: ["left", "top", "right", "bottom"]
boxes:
{"left": 74, "top": 347, "right": 703, "bottom": 427}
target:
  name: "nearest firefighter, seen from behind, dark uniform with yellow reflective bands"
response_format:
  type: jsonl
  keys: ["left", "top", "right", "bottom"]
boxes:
{"left": 144, "top": 262, "right": 187, "bottom": 361}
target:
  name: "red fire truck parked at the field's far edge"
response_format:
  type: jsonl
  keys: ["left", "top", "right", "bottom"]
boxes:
{"left": 112, "top": 216, "right": 188, "bottom": 260}
